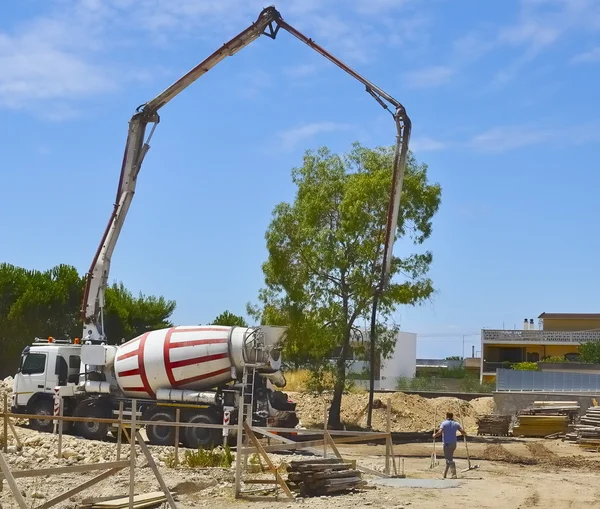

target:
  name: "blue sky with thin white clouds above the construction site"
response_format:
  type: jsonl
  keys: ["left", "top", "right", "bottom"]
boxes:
{"left": 0, "top": 0, "right": 600, "bottom": 357}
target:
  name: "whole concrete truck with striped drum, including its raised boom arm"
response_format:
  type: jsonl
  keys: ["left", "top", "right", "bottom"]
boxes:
{"left": 11, "top": 7, "right": 410, "bottom": 448}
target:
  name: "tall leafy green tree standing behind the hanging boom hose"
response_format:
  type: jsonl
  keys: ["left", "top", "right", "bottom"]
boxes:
{"left": 248, "top": 143, "right": 441, "bottom": 426}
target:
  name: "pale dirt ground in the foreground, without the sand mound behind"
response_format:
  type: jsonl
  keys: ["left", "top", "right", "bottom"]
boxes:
{"left": 0, "top": 428, "right": 600, "bottom": 509}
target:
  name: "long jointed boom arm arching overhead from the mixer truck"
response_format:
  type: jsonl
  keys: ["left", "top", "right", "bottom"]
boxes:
{"left": 81, "top": 6, "right": 411, "bottom": 343}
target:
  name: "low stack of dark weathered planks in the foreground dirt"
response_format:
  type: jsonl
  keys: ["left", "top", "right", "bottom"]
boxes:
{"left": 287, "top": 459, "right": 367, "bottom": 497}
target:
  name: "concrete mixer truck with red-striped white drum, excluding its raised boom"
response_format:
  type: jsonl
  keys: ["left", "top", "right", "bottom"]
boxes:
{"left": 12, "top": 325, "right": 298, "bottom": 448}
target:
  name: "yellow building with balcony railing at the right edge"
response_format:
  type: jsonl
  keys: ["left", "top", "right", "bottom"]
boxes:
{"left": 481, "top": 313, "right": 600, "bottom": 381}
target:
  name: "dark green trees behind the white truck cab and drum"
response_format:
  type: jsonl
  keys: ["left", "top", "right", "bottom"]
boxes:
{"left": 0, "top": 263, "right": 175, "bottom": 377}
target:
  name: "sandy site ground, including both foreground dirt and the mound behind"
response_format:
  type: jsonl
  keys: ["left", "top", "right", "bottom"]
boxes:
{"left": 0, "top": 383, "right": 600, "bottom": 509}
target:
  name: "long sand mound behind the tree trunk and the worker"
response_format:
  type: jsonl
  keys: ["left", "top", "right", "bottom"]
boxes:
{"left": 288, "top": 392, "right": 495, "bottom": 431}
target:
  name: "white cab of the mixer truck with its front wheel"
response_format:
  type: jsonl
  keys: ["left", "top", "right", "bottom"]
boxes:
{"left": 11, "top": 338, "right": 81, "bottom": 431}
